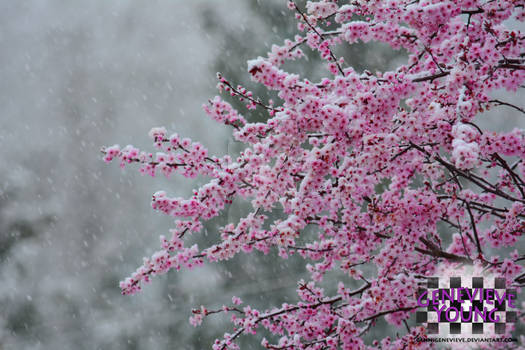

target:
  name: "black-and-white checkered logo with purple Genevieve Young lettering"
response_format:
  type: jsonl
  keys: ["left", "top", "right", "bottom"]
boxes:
{"left": 416, "top": 277, "right": 517, "bottom": 335}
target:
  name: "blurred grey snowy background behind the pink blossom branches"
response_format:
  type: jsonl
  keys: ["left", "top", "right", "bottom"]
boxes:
{"left": 0, "top": 0, "right": 520, "bottom": 349}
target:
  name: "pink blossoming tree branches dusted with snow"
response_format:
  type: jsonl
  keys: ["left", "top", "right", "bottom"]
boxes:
{"left": 103, "top": 0, "right": 525, "bottom": 349}
